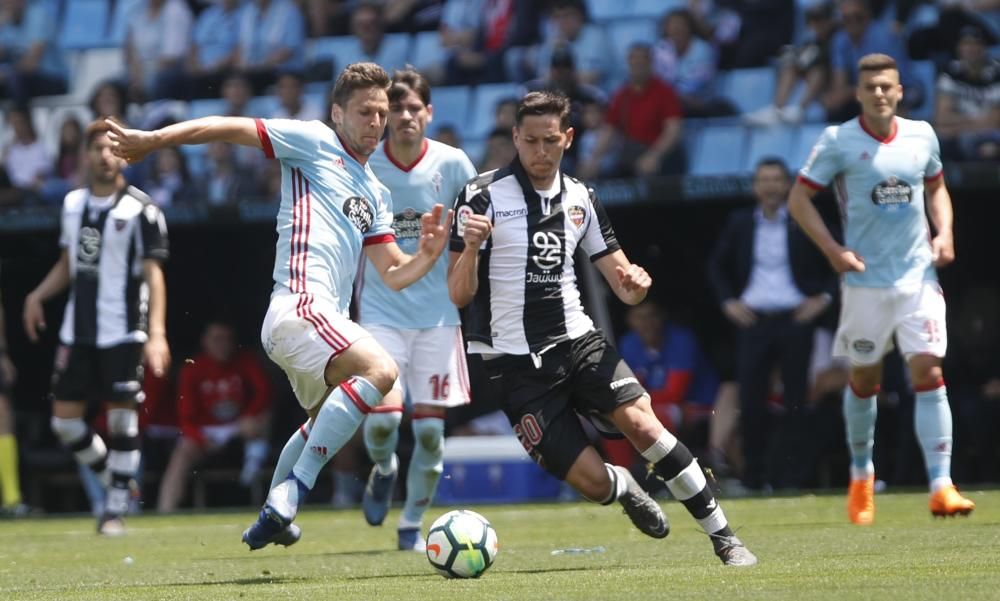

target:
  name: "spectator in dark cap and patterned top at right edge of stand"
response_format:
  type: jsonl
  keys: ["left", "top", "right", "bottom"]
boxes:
{"left": 934, "top": 25, "right": 1000, "bottom": 161}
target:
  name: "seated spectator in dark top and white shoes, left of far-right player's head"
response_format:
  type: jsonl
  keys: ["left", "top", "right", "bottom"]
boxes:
{"left": 745, "top": 0, "right": 840, "bottom": 126}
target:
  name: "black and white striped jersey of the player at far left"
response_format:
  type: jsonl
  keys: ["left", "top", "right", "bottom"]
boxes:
{"left": 59, "top": 186, "right": 168, "bottom": 348}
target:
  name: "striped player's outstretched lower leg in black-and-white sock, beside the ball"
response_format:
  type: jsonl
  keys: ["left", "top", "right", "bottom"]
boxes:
{"left": 611, "top": 395, "right": 757, "bottom": 566}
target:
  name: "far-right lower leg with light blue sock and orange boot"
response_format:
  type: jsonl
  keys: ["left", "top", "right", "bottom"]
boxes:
{"left": 909, "top": 354, "right": 976, "bottom": 517}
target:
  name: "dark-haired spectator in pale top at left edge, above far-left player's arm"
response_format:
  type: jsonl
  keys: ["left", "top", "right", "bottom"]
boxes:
{"left": 0, "top": 105, "right": 52, "bottom": 202}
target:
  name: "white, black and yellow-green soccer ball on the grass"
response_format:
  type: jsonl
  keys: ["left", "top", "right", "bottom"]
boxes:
{"left": 427, "top": 509, "right": 497, "bottom": 578}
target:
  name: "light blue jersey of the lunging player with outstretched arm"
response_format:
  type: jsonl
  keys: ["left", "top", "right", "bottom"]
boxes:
{"left": 257, "top": 119, "right": 394, "bottom": 315}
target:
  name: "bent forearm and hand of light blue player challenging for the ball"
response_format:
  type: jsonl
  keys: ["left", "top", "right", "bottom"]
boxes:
{"left": 365, "top": 204, "right": 452, "bottom": 290}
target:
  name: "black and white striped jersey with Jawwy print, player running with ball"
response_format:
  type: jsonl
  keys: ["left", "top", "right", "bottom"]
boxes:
{"left": 450, "top": 158, "right": 619, "bottom": 355}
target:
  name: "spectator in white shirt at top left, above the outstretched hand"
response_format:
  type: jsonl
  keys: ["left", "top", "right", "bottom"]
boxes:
{"left": 125, "top": 0, "right": 193, "bottom": 102}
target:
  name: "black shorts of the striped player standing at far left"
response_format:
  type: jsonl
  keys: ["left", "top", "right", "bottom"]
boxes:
{"left": 51, "top": 342, "right": 143, "bottom": 403}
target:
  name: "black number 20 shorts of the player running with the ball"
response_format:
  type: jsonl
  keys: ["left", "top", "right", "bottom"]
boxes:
{"left": 483, "top": 331, "right": 646, "bottom": 479}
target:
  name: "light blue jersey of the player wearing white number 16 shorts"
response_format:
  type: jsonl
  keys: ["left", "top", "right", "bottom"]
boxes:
{"left": 358, "top": 140, "right": 476, "bottom": 329}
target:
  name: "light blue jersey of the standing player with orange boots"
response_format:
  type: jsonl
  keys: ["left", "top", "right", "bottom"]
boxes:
{"left": 799, "top": 117, "right": 943, "bottom": 288}
